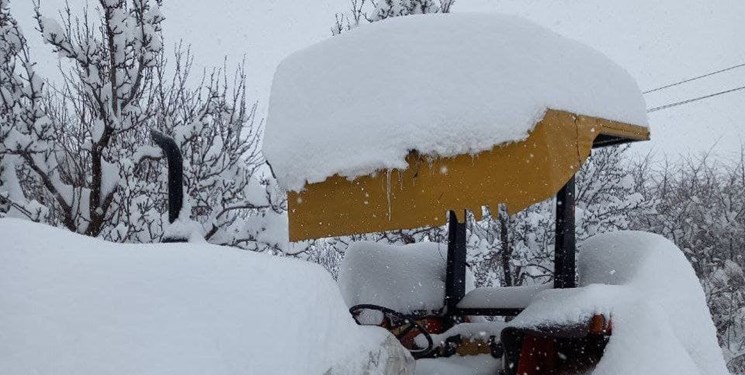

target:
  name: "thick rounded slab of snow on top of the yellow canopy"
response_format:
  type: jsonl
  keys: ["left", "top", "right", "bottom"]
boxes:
{"left": 264, "top": 14, "right": 647, "bottom": 190}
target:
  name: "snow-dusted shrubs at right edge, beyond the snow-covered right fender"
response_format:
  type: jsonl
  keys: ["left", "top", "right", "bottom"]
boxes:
{"left": 632, "top": 154, "right": 745, "bottom": 374}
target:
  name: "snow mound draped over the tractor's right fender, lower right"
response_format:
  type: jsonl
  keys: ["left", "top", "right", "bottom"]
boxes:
{"left": 510, "top": 232, "right": 728, "bottom": 375}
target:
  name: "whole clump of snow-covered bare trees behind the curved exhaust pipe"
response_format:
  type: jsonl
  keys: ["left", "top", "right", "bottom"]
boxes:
{"left": 0, "top": 0, "right": 283, "bottom": 250}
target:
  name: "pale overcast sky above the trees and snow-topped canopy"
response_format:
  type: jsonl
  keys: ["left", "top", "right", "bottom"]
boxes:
{"left": 11, "top": 0, "right": 745, "bottom": 159}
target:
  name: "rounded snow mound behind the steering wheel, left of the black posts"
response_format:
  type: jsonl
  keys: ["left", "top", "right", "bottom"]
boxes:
{"left": 338, "top": 242, "right": 473, "bottom": 313}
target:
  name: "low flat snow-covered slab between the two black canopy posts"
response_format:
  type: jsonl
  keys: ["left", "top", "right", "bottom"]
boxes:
{"left": 450, "top": 284, "right": 552, "bottom": 316}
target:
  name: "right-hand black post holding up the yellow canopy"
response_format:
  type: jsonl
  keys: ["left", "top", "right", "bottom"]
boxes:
{"left": 554, "top": 176, "right": 577, "bottom": 288}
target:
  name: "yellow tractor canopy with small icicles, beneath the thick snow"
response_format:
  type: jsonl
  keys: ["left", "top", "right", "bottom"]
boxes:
{"left": 288, "top": 109, "right": 649, "bottom": 241}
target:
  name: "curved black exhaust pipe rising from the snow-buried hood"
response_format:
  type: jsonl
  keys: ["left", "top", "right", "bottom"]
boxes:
{"left": 150, "top": 130, "right": 187, "bottom": 242}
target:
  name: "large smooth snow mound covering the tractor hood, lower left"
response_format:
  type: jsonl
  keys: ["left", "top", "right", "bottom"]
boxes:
{"left": 0, "top": 219, "right": 411, "bottom": 375}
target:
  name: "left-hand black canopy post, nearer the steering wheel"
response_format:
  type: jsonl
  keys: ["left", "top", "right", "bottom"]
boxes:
{"left": 445, "top": 211, "right": 466, "bottom": 316}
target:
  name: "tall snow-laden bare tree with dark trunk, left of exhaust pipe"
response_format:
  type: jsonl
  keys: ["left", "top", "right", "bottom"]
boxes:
{"left": 4, "top": 0, "right": 169, "bottom": 236}
